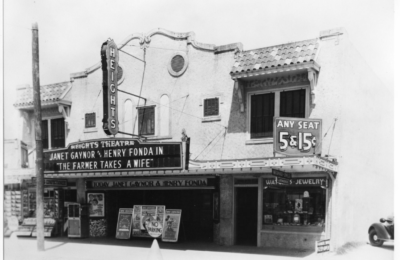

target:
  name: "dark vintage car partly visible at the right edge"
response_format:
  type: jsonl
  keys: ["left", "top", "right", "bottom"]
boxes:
{"left": 368, "top": 217, "right": 394, "bottom": 246}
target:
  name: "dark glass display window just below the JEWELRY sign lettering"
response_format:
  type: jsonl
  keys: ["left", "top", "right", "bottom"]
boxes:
{"left": 263, "top": 179, "right": 326, "bottom": 228}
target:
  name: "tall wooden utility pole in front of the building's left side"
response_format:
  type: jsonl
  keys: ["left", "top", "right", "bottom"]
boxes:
{"left": 32, "top": 23, "right": 44, "bottom": 251}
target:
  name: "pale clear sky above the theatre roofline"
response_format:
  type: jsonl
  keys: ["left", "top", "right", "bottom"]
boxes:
{"left": 3, "top": 0, "right": 394, "bottom": 139}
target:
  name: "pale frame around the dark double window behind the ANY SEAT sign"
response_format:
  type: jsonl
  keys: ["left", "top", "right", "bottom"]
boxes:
{"left": 246, "top": 83, "right": 311, "bottom": 144}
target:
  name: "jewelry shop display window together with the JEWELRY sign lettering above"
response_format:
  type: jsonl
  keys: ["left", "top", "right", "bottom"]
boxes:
{"left": 263, "top": 177, "right": 327, "bottom": 232}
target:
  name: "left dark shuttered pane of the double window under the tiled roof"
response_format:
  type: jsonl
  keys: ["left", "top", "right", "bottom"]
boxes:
{"left": 250, "top": 93, "right": 275, "bottom": 138}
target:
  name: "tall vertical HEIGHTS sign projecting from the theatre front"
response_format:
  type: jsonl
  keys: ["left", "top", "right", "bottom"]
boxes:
{"left": 101, "top": 39, "right": 119, "bottom": 135}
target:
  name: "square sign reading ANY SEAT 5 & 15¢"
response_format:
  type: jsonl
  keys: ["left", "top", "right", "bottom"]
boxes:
{"left": 274, "top": 117, "right": 322, "bottom": 156}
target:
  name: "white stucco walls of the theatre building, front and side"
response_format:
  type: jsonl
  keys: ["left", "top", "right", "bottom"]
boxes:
{"left": 12, "top": 28, "right": 393, "bottom": 252}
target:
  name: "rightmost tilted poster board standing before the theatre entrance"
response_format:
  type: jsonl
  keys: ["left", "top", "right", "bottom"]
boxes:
{"left": 161, "top": 209, "right": 182, "bottom": 242}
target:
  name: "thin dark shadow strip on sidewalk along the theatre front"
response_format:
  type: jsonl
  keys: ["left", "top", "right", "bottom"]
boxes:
{"left": 11, "top": 237, "right": 315, "bottom": 258}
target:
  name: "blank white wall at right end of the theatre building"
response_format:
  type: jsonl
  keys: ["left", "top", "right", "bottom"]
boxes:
{"left": 310, "top": 29, "right": 394, "bottom": 247}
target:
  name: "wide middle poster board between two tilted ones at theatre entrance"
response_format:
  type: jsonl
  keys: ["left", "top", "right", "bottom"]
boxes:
{"left": 132, "top": 205, "right": 165, "bottom": 237}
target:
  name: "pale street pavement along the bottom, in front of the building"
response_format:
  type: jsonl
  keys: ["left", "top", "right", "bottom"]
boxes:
{"left": 3, "top": 235, "right": 394, "bottom": 260}
